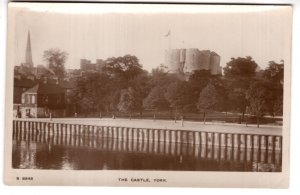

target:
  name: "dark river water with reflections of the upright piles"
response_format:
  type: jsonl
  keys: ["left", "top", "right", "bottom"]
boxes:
{"left": 12, "top": 133, "right": 281, "bottom": 172}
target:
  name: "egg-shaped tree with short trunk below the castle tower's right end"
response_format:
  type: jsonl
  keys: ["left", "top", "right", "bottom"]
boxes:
{"left": 197, "top": 83, "right": 221, "bottom": 121}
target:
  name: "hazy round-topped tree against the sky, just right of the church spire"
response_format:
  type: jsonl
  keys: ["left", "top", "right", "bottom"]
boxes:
{"left": 43, "top": 48, "right": 68, "bottom": 78}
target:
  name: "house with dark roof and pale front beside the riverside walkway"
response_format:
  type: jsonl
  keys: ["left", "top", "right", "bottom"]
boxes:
{"left": 20, "top": 83, "right": 65, "bottom": 118}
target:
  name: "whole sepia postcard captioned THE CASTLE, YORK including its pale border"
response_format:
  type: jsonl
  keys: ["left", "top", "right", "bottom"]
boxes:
{"left": 5, "top": 3, "right": 292, "bottom": 188}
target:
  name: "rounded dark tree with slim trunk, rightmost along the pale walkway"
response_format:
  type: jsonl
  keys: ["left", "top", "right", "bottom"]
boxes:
{"left": 246, "top": 81, "right": 268, "bottom": 127}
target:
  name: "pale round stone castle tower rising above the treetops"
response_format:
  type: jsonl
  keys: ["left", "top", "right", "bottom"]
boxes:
{"left": 165, "top": 48, "right": 222, "bottom": 75}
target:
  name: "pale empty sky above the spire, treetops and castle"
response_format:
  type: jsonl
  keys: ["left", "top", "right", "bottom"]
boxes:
{"left": 9, "top": 3, "right": 291, "bottom": 71}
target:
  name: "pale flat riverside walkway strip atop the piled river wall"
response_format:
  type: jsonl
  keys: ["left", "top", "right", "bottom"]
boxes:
{"left": 18, "top": 118, "right": 282, "bottom": 135}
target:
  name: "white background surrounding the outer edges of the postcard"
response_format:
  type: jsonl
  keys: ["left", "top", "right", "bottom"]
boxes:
{"left": 0, "top": 0, "right": 300, "bottom": 194}
